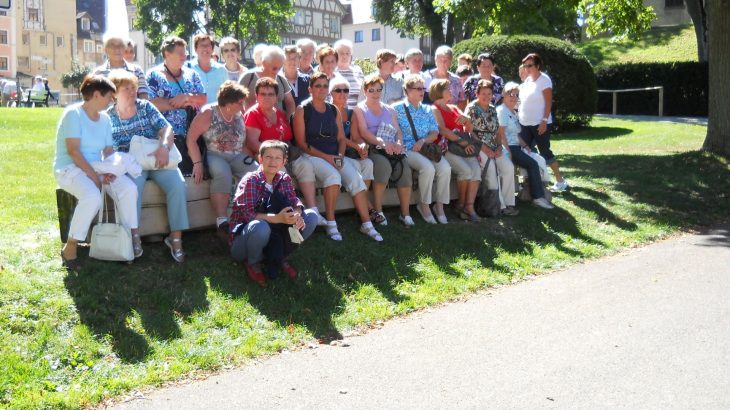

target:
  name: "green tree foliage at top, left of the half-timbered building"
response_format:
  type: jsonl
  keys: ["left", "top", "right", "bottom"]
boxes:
{"left": 134, "top": 0, "right": 294, "bottom": 51}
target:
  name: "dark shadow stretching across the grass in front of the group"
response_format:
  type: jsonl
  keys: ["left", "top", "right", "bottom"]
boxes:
{"left": 65, "top": 152, "right": 730, "bottom": 362}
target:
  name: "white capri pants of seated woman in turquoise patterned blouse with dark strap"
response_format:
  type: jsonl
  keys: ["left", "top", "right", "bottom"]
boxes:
{"left": 406, "top": 151, "right": 451, "bottom": 204}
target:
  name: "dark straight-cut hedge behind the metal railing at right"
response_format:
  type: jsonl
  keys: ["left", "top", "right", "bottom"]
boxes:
{"left": 596, "top": 62, "right": 709, "bottom": 117}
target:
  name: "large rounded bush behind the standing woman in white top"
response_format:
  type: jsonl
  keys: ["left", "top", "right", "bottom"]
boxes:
{"left": 453, "top": 36, "right": 598, "bottom": 130}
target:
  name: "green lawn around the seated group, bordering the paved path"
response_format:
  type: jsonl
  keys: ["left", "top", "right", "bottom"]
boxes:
{"left": 0, "top": 109, "right": 730, "bottom": 408}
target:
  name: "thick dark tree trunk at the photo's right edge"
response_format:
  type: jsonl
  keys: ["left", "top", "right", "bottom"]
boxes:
{"left": 703, "top": 0, "right": 730, "bottom": 157}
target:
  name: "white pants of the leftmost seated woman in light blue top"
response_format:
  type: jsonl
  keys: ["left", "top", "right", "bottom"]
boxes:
{"left": 54, "top": 164, "right": 138, "bottom": 241}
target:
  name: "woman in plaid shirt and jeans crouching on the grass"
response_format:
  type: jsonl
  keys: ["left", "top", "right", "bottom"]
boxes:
{"left": 229, "top": 140, "right": 319, "bottom": 286}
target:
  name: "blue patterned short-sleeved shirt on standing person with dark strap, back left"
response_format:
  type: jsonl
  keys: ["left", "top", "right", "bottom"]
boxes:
{"left": 147, "top": 64, "right": 205, "bottom": 135}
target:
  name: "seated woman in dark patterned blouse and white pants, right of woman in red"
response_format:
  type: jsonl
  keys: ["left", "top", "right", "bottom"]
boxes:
{"left": 466, "top": 80, "right": 519, "bottom": 216}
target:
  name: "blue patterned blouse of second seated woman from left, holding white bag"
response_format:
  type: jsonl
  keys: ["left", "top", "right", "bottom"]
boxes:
{"left": 107, "top": 99, "right": 170, "bottom": 152}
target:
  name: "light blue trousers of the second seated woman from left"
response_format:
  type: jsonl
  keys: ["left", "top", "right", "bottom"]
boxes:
{"left": 133, "top": 168, "right": 190, "bottom": 231}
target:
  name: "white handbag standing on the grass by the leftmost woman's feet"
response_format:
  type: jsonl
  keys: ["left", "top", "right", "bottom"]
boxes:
{"left": 89, "top": 185, "right": 134, "bottom": 262}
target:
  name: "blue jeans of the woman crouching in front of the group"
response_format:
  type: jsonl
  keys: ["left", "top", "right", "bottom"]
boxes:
{"left": 231, "top": 209, "right": 319, "bottom": 265}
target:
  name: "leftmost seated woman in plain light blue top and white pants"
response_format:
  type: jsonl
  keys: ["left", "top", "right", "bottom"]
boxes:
{"left": 53, "top": 76, "right": 141, "bottom": 268}
